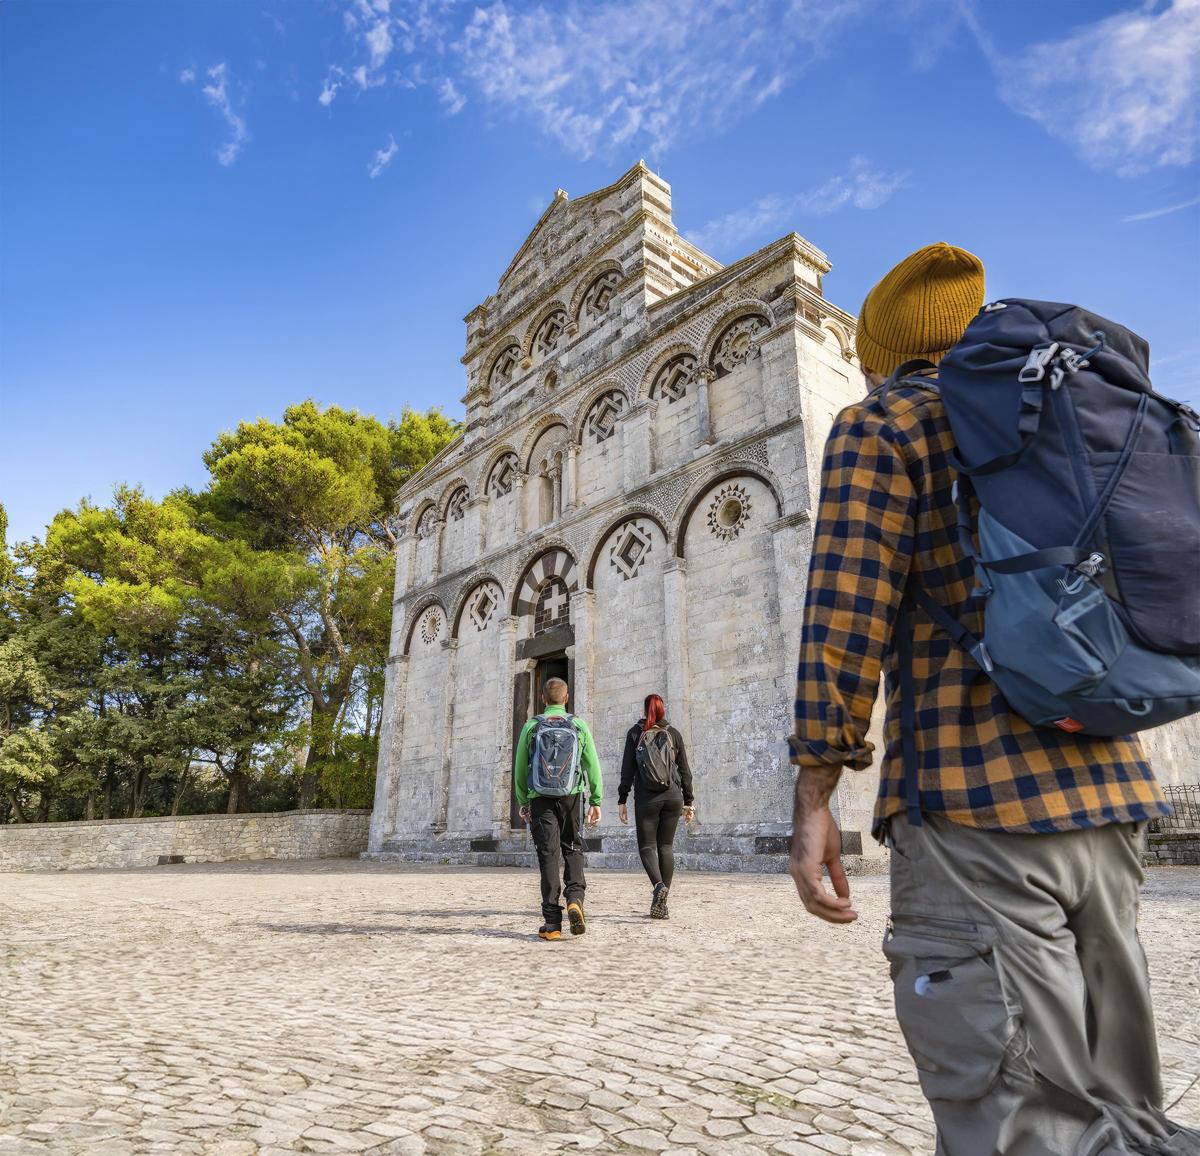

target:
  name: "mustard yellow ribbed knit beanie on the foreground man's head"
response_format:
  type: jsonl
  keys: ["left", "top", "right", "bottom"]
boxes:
{"left": 854, "top": 241, "right": 983, "bottom": 376}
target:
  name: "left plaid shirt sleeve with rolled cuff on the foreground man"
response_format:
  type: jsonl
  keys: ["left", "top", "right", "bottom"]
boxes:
{"left": 790, "top": 401, "right": 917, "bottom": 769}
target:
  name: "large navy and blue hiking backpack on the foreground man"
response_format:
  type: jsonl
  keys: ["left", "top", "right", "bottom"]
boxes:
{"left": 892, "top": 299, "right": 1200, "bottom": 787}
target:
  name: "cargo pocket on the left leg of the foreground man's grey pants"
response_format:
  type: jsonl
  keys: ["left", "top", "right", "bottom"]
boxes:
{"left": 883, "top": 915, "right": 1026, "bottom": 1101}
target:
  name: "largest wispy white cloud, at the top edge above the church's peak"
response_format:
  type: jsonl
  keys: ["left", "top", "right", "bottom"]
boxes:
{"left": 319, "top": 0, "right": 877, "bottom": 157}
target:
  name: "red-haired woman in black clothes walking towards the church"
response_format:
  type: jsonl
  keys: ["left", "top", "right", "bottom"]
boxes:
{"left": 617, "top": 694, "right": 695, "bottom": 920}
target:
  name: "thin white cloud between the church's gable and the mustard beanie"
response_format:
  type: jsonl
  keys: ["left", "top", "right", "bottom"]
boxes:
{"left": 688, "top": 156, "right": 908, "bottom": 254}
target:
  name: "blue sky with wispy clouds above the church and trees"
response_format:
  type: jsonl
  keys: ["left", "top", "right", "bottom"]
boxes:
{"left": 0, "top": 0, "right": 1200, "bottom": 540}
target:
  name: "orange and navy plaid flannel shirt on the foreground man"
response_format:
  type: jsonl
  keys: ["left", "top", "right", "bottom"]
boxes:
{"left": 791, "top": 385, "right": 1169, "bottom": 837}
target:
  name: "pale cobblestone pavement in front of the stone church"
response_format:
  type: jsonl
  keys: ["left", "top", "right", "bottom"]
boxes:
{"left": 0, "top": 861, "right": 1200, "bottom": 1156}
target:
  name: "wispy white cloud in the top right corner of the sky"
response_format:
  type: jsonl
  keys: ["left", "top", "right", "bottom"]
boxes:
{"left": 959, "top": 0, "right": 1200, "bottom": 176}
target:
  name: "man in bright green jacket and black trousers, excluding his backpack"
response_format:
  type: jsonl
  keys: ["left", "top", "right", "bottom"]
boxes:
{"left": 514, "top": 678, "right": 604, "bottom": 940}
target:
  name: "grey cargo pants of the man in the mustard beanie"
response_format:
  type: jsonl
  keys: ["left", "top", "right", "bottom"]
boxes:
{"left": 883, "top": 815, "right": 1200, "bottom": 1156}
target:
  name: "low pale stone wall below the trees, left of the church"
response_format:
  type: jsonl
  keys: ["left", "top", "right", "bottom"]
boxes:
{"left": 0, "top": 810, "right": 371, "bottom": 872}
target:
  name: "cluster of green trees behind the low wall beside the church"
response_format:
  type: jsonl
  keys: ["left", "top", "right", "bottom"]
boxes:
{"left": 0, "top": 401, "right": 457, "bottom": 821}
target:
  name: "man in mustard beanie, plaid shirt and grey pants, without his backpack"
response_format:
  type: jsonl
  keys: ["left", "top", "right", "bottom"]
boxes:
{"left": 788, "top": 242, "right": 1196, "bottom": 1156}
